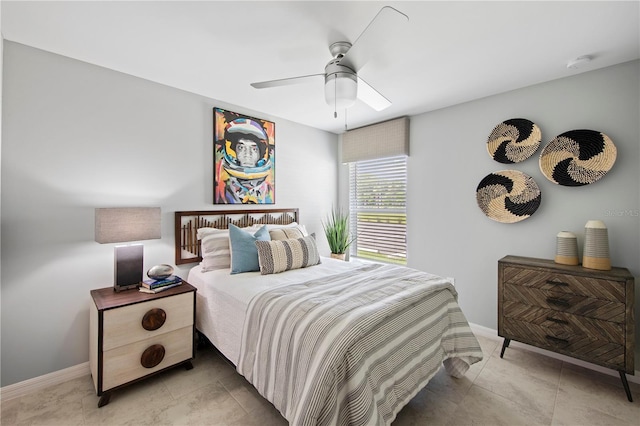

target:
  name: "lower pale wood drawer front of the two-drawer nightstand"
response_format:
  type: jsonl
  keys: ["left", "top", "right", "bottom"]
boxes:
{"left": 102, "top": 326, "right": 193, "bottom": 391}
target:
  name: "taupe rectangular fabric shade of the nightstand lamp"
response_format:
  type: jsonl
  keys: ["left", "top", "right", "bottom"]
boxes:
{"left": 95, "top": 207, "right": 161, "bottom": 244}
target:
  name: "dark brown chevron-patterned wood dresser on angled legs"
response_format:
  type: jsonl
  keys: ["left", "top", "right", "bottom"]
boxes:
{"left": 498, "top": 256, "right": 635, "bottom": 401}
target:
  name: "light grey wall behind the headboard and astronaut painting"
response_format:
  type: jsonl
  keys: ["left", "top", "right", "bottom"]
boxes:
{"left": 1, "top": 42, "right": 337, "bottom": 386}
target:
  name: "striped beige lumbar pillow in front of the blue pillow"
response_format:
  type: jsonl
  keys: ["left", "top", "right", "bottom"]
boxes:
{"left": 256, "top": 236, "right": 320, "bottom": 275}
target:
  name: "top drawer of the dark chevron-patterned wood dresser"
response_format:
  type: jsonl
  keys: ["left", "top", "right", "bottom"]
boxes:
{"left": 503, "top": 266, "right": 626, "bottom": 303}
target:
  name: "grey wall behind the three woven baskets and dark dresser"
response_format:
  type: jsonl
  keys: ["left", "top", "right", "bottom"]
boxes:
{"left": 408, "top": 61, "right": 640, "bottom": 362}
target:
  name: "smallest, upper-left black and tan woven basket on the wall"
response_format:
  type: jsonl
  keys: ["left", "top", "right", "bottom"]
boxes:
{"left": 487, "top": 118, "right": 542, "bottom": 164}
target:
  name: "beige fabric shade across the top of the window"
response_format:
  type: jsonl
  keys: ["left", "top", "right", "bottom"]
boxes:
{"left": 342, "top": 117, "right": 409, "bottom": 163}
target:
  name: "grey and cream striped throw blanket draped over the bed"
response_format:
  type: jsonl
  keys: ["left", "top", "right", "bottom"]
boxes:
{"left": 237, "top": 264, "right": 482, "bottom": 426}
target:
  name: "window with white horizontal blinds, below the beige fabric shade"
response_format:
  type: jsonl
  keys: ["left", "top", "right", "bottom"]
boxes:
{"left": 349, "top": 155, "right": 407, "bottom": 265}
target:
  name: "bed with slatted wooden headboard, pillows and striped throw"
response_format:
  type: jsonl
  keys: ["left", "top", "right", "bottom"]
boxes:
{"left": 175, "top": 209, "right": 482, "bottom": 425}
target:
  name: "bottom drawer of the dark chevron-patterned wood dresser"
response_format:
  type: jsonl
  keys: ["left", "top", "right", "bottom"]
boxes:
{"left": 503, "top": 317, "right": 625, "bottom": 370}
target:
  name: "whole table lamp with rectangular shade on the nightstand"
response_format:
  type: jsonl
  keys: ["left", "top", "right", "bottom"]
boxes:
{"left": 95, "top": 207, "right": 161, "bottom": 291}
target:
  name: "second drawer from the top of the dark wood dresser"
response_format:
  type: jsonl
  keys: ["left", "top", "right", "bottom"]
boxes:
{"left": 502, "top": 283, "right": 625, "bottom": 323}
